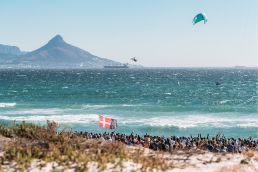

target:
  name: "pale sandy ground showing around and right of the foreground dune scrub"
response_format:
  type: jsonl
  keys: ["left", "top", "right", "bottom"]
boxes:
{"left": 0, "top": 137, "right": 258, "bottom": 172}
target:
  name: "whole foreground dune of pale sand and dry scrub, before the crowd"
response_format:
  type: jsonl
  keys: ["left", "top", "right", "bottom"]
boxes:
{"left": 0, "top": 122, "right": 258, "bottom": 172}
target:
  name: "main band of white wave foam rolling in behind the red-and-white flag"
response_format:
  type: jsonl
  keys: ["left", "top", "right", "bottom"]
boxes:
{"left": 0, "top": 114, "right": 258, "bottom": 128}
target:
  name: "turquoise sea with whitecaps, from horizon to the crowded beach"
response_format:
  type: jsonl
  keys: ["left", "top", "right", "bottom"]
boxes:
{"left": 0, "top": 68, "right": 258, "bottom": 138}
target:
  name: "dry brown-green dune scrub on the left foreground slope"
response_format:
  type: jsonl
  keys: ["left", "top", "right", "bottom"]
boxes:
{"left": 0, "top": 122, "right": 174, "bottom": 171}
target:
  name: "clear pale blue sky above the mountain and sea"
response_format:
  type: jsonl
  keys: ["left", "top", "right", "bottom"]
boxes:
{"left": 0, "top": 0, "right": 258, "bottom": 67}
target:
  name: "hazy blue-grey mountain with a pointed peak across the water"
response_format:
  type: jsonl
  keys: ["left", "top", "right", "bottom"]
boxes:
{"left": 2, "top": 35, "right": 122, "bottom": 68}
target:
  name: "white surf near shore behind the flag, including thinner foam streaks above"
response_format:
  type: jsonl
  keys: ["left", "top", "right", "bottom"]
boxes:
{"left": 0, "top": 109, "right": 258, "bottom": 129}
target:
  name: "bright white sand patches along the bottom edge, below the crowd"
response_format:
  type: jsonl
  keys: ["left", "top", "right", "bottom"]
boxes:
{"left": 2, "top": 152, "right": 258, "bottom": 172}
